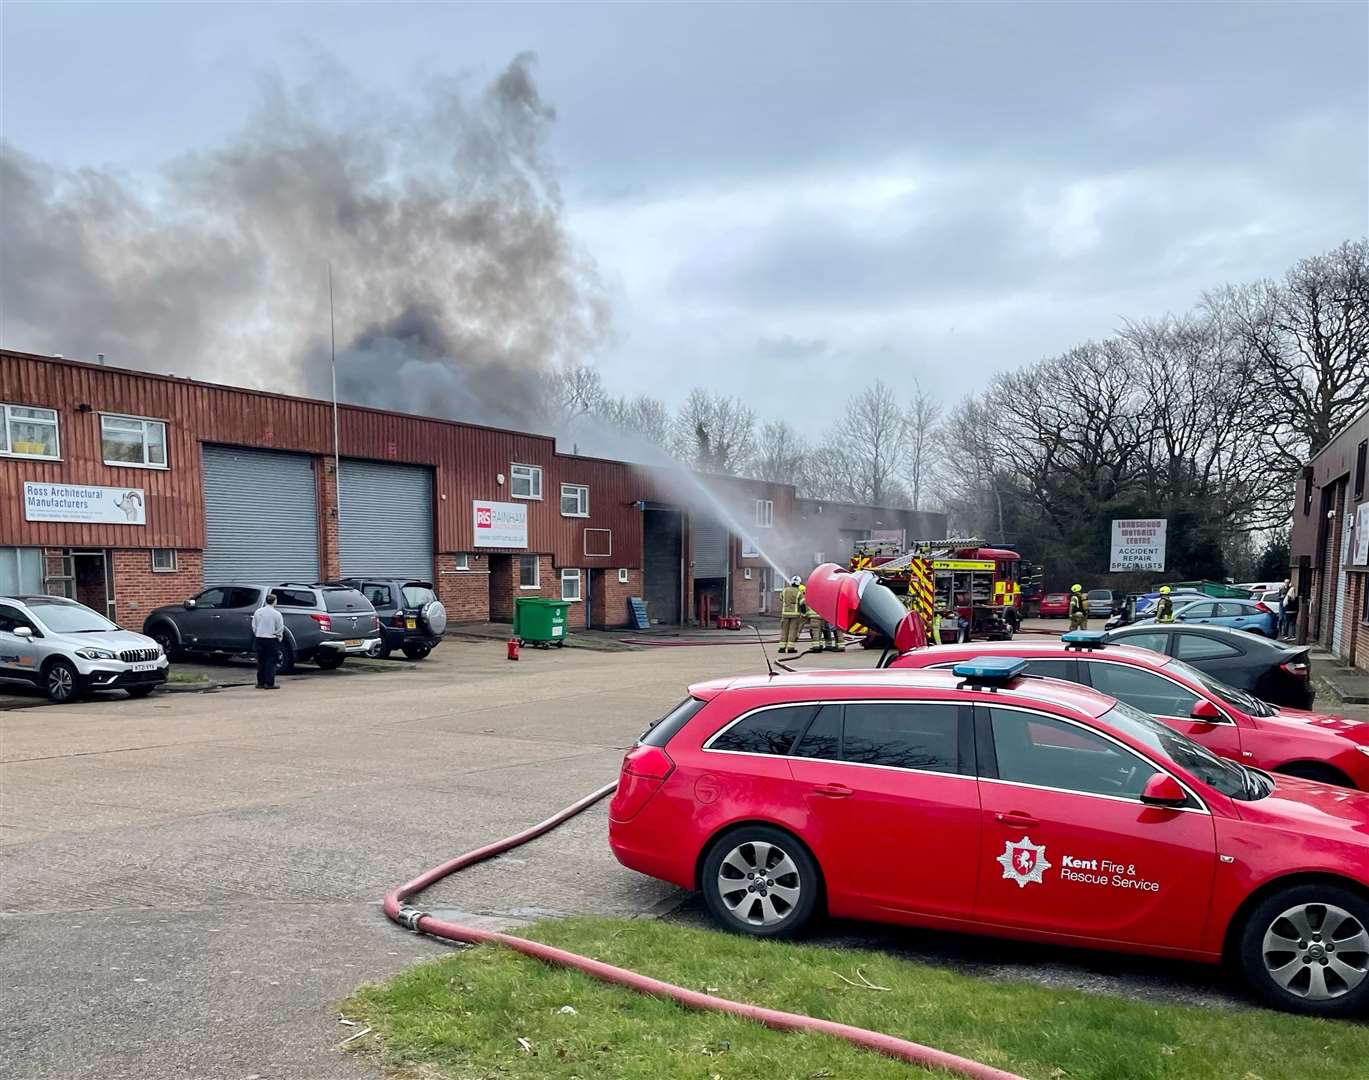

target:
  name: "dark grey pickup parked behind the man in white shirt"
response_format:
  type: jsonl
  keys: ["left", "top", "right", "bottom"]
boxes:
{"left": 142, "top": 582, "right": 381, "bottom": 672}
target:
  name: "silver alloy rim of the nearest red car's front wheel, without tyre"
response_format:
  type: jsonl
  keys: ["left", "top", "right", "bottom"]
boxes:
{"left": 1261, "top": 903, "right": 1369, "bottom": 1003}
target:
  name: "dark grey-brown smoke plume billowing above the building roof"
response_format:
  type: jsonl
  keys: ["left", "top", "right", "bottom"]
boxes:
{"left": 0, "top": 53, "right": 608, "bottom": 423}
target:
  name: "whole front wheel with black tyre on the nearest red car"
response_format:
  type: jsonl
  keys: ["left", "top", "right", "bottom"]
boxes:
{"left": 1238, "top": 882, "right": 1369, "bottom": 1018}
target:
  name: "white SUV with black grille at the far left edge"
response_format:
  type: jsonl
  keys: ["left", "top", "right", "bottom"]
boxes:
{"left": 0, "top": 595, "right": 170, "bottom": 705}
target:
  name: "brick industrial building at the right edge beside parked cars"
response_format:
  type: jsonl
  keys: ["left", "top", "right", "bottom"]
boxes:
{"left": 1291, "top": 409, "right": 1369, "bottom": 668}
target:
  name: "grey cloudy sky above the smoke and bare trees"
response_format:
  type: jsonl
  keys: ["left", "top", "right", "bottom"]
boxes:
{"left": 0, "top": 3, "right": 1369, "bottom": 426}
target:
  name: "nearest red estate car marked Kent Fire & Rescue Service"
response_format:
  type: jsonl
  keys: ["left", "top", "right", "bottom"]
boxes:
{"left": 609, "top": 660, "right": 1369, "bottom": 1017}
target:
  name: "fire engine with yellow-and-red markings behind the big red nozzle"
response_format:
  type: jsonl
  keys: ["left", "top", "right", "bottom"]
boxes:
{"left": 850, "top": 538, "right": 1023, "bottom": 641}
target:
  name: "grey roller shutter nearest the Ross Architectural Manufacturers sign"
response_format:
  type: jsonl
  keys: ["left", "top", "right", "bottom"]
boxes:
{"left": 204, "top": 446, "right": 319, "bottom": 586}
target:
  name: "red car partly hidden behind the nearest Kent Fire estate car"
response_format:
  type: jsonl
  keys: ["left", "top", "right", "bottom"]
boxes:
{"left": 890, "top": 632, "right": 1369, "bottom": 791}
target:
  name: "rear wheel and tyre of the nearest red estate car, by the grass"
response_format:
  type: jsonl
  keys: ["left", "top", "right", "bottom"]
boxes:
{"left": 702, "top": 825, "right": 821, "bottom": 938}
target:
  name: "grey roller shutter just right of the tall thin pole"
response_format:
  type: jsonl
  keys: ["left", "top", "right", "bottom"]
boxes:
{"left": 338, "top": 460, "right": 433, "bottom": 580}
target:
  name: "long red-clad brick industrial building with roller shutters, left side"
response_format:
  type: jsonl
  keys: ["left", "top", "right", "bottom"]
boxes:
{"left": 0, "top": 352, "right": 945, "bottom": 627}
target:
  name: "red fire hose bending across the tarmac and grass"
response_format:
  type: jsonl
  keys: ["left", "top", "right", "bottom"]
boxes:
{"left": 382, "top": 783, "right": 1023, "bottom": 1080}
